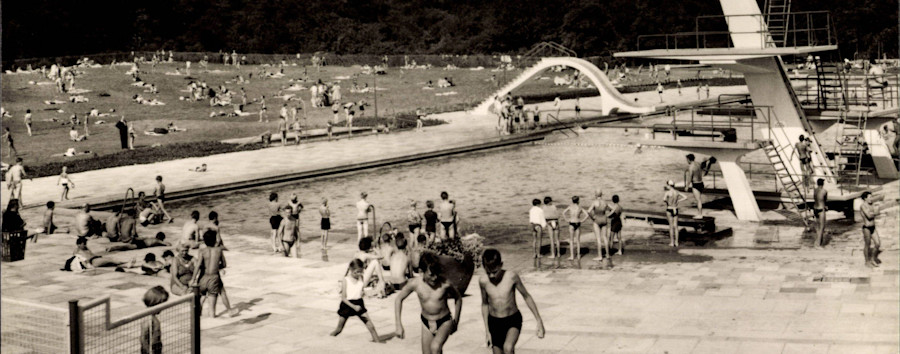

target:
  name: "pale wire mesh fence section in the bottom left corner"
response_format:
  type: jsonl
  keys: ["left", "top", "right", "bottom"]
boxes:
{"left": 0, "top": 297, "right": 69, "bottom": 354}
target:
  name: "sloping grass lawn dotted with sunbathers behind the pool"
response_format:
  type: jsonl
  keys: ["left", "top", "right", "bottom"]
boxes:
{"left": 0, "top": 63, "right": 740, "bottom": 176}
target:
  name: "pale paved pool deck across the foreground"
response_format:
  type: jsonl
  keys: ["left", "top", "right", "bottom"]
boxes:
{"left": 0, "top": 192, "right": 900, "bottom": 354}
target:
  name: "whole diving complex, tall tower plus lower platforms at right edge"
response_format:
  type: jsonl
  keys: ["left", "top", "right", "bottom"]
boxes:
{"left": 614, "top": 0, "right": 897, "bottom": 221}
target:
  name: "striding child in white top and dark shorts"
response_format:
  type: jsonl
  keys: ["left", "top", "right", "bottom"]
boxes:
{"left": 331, "top": 259, "right": 384, "bottom": 343}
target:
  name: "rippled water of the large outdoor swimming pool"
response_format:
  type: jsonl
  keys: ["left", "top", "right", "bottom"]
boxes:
{"left": 170, "top": 129, "right": 771, "bottom": 239}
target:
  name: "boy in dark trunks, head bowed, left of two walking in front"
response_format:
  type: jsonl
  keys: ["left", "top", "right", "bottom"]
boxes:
{"left": 394, "top": 253, "right": 462, "bottom": 354}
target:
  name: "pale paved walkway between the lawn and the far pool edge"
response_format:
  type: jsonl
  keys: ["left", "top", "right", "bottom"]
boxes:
{"left": 0, "top": 86, "right": 746, "bottom": 207}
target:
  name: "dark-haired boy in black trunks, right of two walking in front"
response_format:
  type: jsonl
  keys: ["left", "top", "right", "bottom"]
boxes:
{"left": 478, "top": 248, "right": 544, "bottom": 354}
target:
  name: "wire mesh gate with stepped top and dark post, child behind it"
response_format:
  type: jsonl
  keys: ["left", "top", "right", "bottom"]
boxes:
{"left": 79, "top": 295, "right": 199, "bottom": 354}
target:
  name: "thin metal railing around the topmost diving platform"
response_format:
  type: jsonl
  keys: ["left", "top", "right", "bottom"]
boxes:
{"left": 637, "top": 11, "right": 837, "bottom": 50}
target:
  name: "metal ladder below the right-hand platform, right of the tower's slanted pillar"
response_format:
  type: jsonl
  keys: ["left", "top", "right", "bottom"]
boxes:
{"left": 835, "top": 111, "right": 869, "bottom": 187}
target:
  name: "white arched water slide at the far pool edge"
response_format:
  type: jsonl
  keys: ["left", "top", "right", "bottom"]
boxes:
{"left": 471, "top": 57, "right": 656, "bottom": 115}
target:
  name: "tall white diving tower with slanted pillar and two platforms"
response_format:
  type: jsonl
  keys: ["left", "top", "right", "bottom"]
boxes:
{"left": 614, "top": 0, "right": 837, "bottom": 221}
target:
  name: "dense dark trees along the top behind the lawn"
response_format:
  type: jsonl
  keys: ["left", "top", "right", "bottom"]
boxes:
{"left": 2, "top": 0, "right": 898, "bottom": 62}
